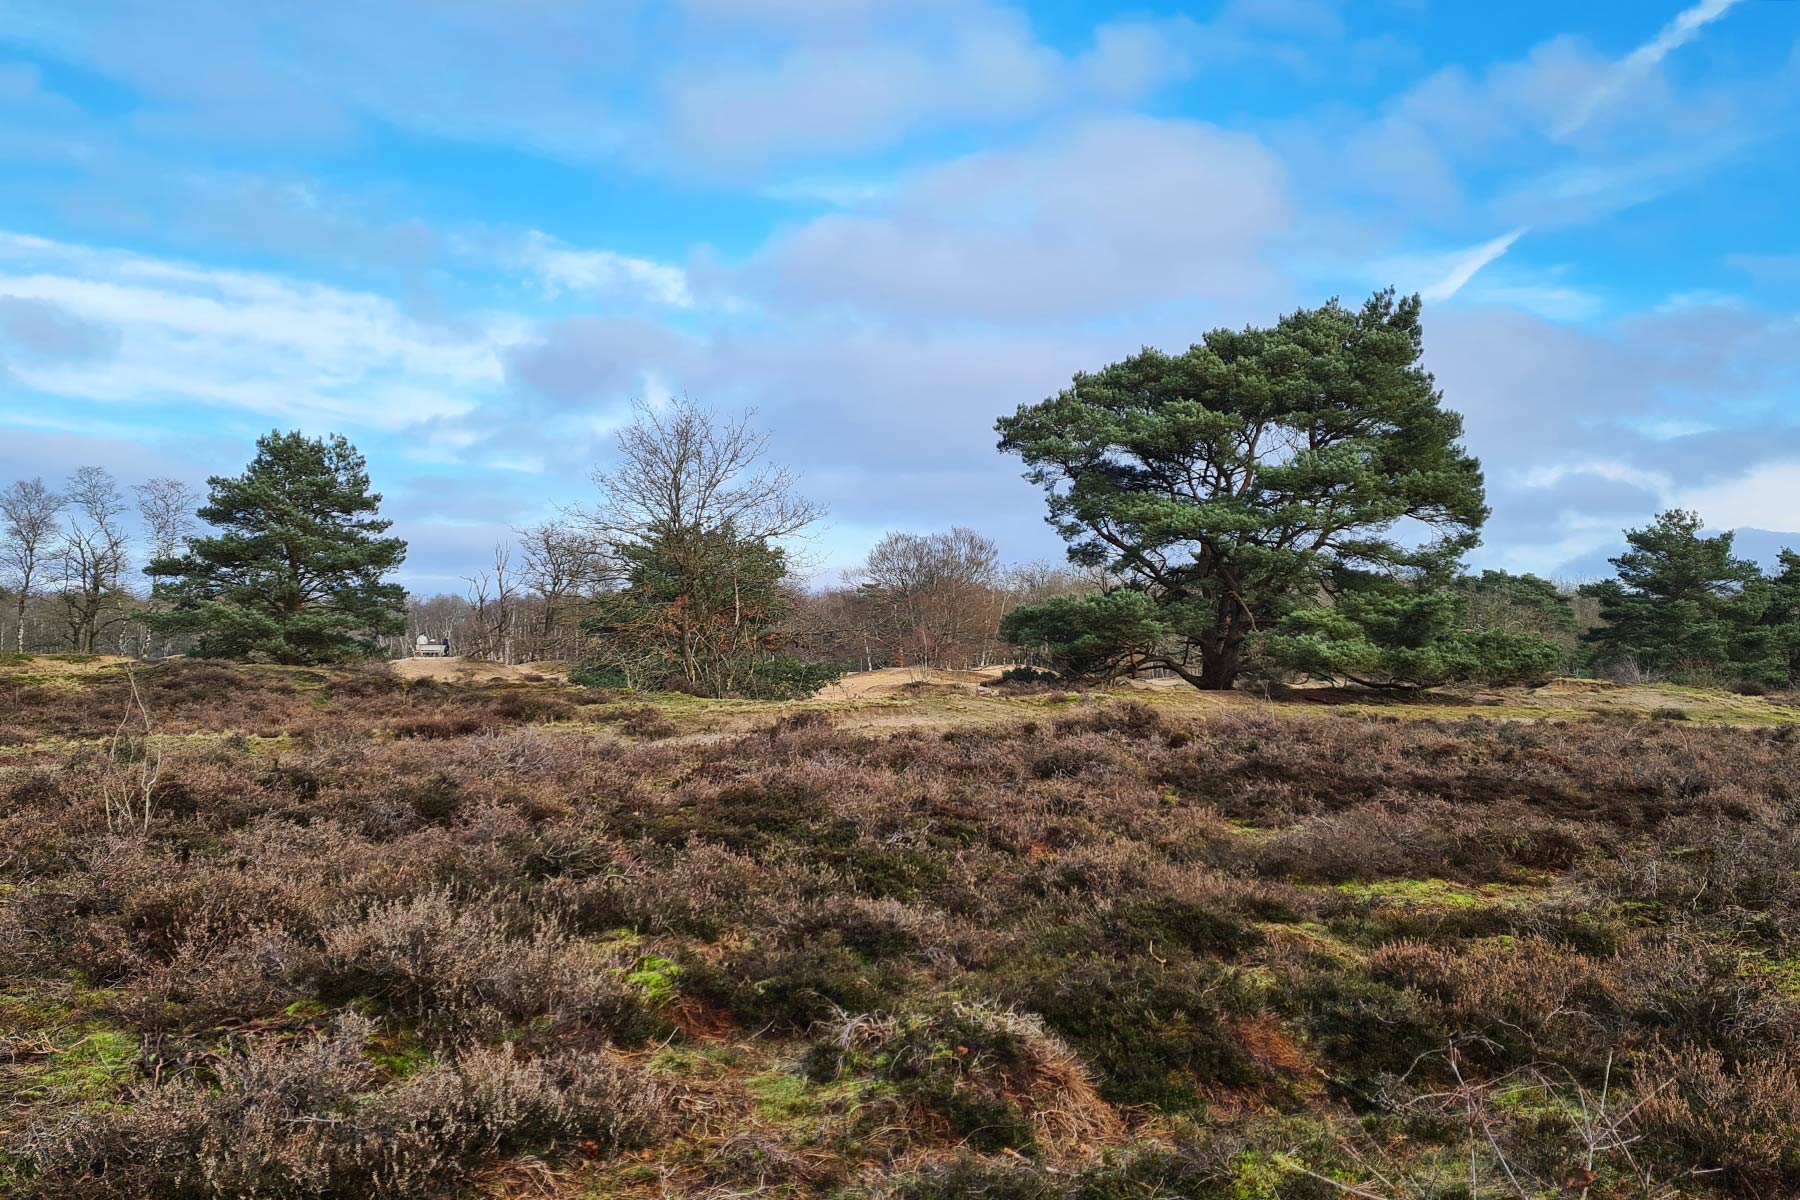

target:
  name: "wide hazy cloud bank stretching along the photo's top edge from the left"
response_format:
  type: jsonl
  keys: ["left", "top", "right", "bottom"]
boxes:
{"left": 0, "top": 0, "right": 1195, "bottom": 175}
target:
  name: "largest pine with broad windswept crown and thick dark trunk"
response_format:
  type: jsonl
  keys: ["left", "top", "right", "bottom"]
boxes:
{"left": 997, "top": 290, "right": 1487, "bottom": 689}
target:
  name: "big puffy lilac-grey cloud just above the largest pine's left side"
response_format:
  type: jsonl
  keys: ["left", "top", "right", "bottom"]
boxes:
{"left": 747, "top": 117, "right": 1291, "bottom": 320}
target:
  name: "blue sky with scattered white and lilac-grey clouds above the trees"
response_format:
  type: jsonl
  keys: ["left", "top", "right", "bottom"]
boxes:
{"left": 0, "top": 0, "right": 1800, "bottom": 592}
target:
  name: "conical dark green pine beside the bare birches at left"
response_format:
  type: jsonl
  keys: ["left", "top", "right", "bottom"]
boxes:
{"left": 149, "top": 430, "right": 407, "bottom": 662}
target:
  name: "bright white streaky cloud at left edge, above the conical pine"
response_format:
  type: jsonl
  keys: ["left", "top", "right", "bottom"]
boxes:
{"left": 0, "top": 232, "right": 502, "bottom": 428}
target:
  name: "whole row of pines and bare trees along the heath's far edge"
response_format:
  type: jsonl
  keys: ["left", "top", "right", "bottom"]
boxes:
{"left": 10, "top": 290, "right": 1800, "bottom": 696}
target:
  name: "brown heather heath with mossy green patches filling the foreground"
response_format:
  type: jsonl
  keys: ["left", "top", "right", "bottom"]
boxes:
{"left": 0, "top": 658, "right": 1800, "bottom": 1200}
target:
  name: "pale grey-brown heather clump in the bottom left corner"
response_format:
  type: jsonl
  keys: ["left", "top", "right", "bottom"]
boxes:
{"left": 18, "top": 1015, "right": 662, "bottom": 1200}
